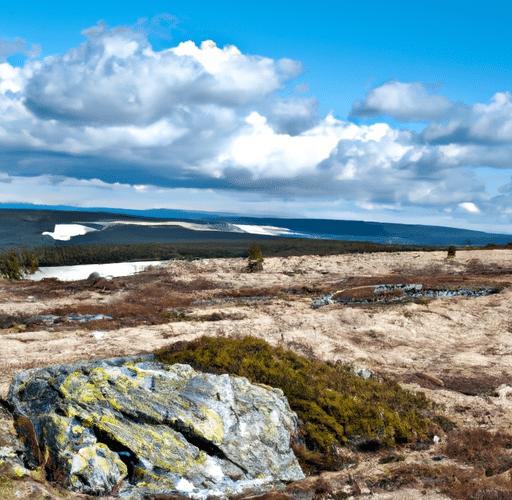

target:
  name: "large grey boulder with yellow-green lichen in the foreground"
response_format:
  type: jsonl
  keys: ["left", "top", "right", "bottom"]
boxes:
{"left": 8, "top": 355, "right": 304, "bottom": 500}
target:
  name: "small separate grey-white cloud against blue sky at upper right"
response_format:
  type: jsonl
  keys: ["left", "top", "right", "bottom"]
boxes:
{"left": 350, "top": 80, "right": 455, "bottom": 122}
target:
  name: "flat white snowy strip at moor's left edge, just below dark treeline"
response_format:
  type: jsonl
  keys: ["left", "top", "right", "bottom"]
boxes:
{"left": 26, "top": 260, "right": 167, "bottom": 281}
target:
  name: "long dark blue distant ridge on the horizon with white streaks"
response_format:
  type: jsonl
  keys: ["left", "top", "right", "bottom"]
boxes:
{"left": 0, "top": 204, "right": 512, "bottom": 250}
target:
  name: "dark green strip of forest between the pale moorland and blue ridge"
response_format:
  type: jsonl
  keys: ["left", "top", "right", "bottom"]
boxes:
{"left": 27, "top": 238, "right": 440, "bottom": 266}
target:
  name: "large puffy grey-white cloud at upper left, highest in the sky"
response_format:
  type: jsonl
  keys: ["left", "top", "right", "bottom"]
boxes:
{"left": 25, "top": 24, "right": 302, "bottom": 125}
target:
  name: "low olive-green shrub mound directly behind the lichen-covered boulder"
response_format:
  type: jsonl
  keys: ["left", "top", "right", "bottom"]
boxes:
{"left": 155, "top": 336, "right": 436, "bottom": 452}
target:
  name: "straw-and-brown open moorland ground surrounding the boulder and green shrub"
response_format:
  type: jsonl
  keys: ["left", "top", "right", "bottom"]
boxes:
{"left": 0, "top": 249, "right": 512, "bottom": 500}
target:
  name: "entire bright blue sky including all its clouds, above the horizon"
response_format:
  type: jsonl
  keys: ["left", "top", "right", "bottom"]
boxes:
{"left": 0, "top": 0, "right": 512, "bottom": 234}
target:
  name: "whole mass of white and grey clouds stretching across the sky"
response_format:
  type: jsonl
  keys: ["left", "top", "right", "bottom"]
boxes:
{"left": 0, "top": 23, "right": 512, "bottom": 230}
